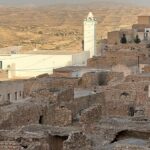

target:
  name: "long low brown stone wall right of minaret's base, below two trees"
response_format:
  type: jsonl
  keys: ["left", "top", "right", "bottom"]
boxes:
{"left": 87, "top": 51, "right": 150, "bottom": 69}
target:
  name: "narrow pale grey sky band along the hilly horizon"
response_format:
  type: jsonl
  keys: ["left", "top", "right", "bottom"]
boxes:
{"left": 0, "top": 0, "right": 150, "bottom": 7}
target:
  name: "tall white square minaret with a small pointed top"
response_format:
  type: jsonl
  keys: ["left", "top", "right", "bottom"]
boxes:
{"left": 84, "top": 12, "right": 97, "bottom": 58}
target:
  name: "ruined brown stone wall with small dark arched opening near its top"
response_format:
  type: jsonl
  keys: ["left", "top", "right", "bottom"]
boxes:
{"left": 103, "top": 89, "right": 136, "bottom": 117}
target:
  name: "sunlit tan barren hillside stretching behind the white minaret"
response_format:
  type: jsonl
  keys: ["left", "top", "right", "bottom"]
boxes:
{"left": 0, "top": 3, "right": 150, "bottom": 50}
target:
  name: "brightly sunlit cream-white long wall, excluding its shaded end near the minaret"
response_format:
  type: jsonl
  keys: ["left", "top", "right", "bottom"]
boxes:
{"left": 0, "top": 54, "right": 72, "bottom": 77}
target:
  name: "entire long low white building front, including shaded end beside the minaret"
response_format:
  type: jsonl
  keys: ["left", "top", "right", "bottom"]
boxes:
{"left": 0, "top": 52, "right": 90, "bottom": 78}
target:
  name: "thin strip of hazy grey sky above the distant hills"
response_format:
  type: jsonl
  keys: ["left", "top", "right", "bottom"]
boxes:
{"left": 0, "top": 0, "right": 150, "bottom": 6}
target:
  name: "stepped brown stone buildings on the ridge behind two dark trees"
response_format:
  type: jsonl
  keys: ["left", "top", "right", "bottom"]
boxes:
{"left": 107, "top": 16, "right": 150, "bottom": 45}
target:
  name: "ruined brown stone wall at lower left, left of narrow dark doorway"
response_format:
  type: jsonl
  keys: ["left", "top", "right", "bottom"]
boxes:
{"left": 0, "top": 99, "right": 46, "bottom": 128}
